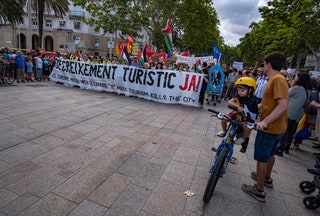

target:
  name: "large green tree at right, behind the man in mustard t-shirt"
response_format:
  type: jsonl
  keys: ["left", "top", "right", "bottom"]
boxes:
{"left": 239, "top": 0, "right": 320, "bottom": 69}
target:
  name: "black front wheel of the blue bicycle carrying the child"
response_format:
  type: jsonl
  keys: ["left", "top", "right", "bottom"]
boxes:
{"left": 202, "top": 146, "right": 228, "bottom": 203}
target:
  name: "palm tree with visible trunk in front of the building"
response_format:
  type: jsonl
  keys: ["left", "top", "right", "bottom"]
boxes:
{"left": 30, "top": 0, "right": 69, "bottom": 48}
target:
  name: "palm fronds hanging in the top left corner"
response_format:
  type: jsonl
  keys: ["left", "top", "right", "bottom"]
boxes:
{"left": 0, "top": 0, "right": 25, "bottom": 26}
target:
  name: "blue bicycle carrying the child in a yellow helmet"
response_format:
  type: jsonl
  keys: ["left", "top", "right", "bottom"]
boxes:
{"left": 202, "top": 107, "right": 256, "bottom": 203}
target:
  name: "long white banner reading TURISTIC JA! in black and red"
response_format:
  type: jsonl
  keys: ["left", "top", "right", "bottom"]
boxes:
{"left": 50, "top": 59, "right": 203, "bottom": 107}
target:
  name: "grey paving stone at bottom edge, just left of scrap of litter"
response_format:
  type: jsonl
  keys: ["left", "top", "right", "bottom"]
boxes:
{"left": 143, "top": 181, "right": 187, "bottom": 216}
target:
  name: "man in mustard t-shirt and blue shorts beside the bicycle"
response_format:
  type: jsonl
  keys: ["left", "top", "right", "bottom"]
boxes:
{"left": 242, "top": 52, "right": 288, "bottom": 202}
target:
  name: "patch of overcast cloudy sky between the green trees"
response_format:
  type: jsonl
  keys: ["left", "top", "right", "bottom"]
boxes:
{"left": 213, "top": 0, "right": 267, "bottom": 46}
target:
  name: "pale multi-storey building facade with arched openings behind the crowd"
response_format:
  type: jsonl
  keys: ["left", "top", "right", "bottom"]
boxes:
{"left": 0, "top": 2, "right": 149, "bottom": 56}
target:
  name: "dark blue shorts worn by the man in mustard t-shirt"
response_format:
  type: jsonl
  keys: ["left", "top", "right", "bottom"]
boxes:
{"left": 254, "top": 131, "right": 283, "bottom": 163}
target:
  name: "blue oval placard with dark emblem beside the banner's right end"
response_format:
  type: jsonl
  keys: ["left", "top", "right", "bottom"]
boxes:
{"left": 206, "top": 65, "right": 225, "bottom": 106}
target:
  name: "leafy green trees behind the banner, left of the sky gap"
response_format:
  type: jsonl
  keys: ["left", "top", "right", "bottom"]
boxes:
{"left": 72, "top": 0, "right": 223, "bottom": 55}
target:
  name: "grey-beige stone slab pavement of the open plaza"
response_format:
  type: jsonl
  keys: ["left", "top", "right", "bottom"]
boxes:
{"left": 0, "top": 82, "right": 320, "bottom": 216}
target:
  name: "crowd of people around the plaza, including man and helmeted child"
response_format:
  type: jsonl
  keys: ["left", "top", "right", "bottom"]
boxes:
{"left": 0, "top": 49, "right": 320, "bottom": 202}
